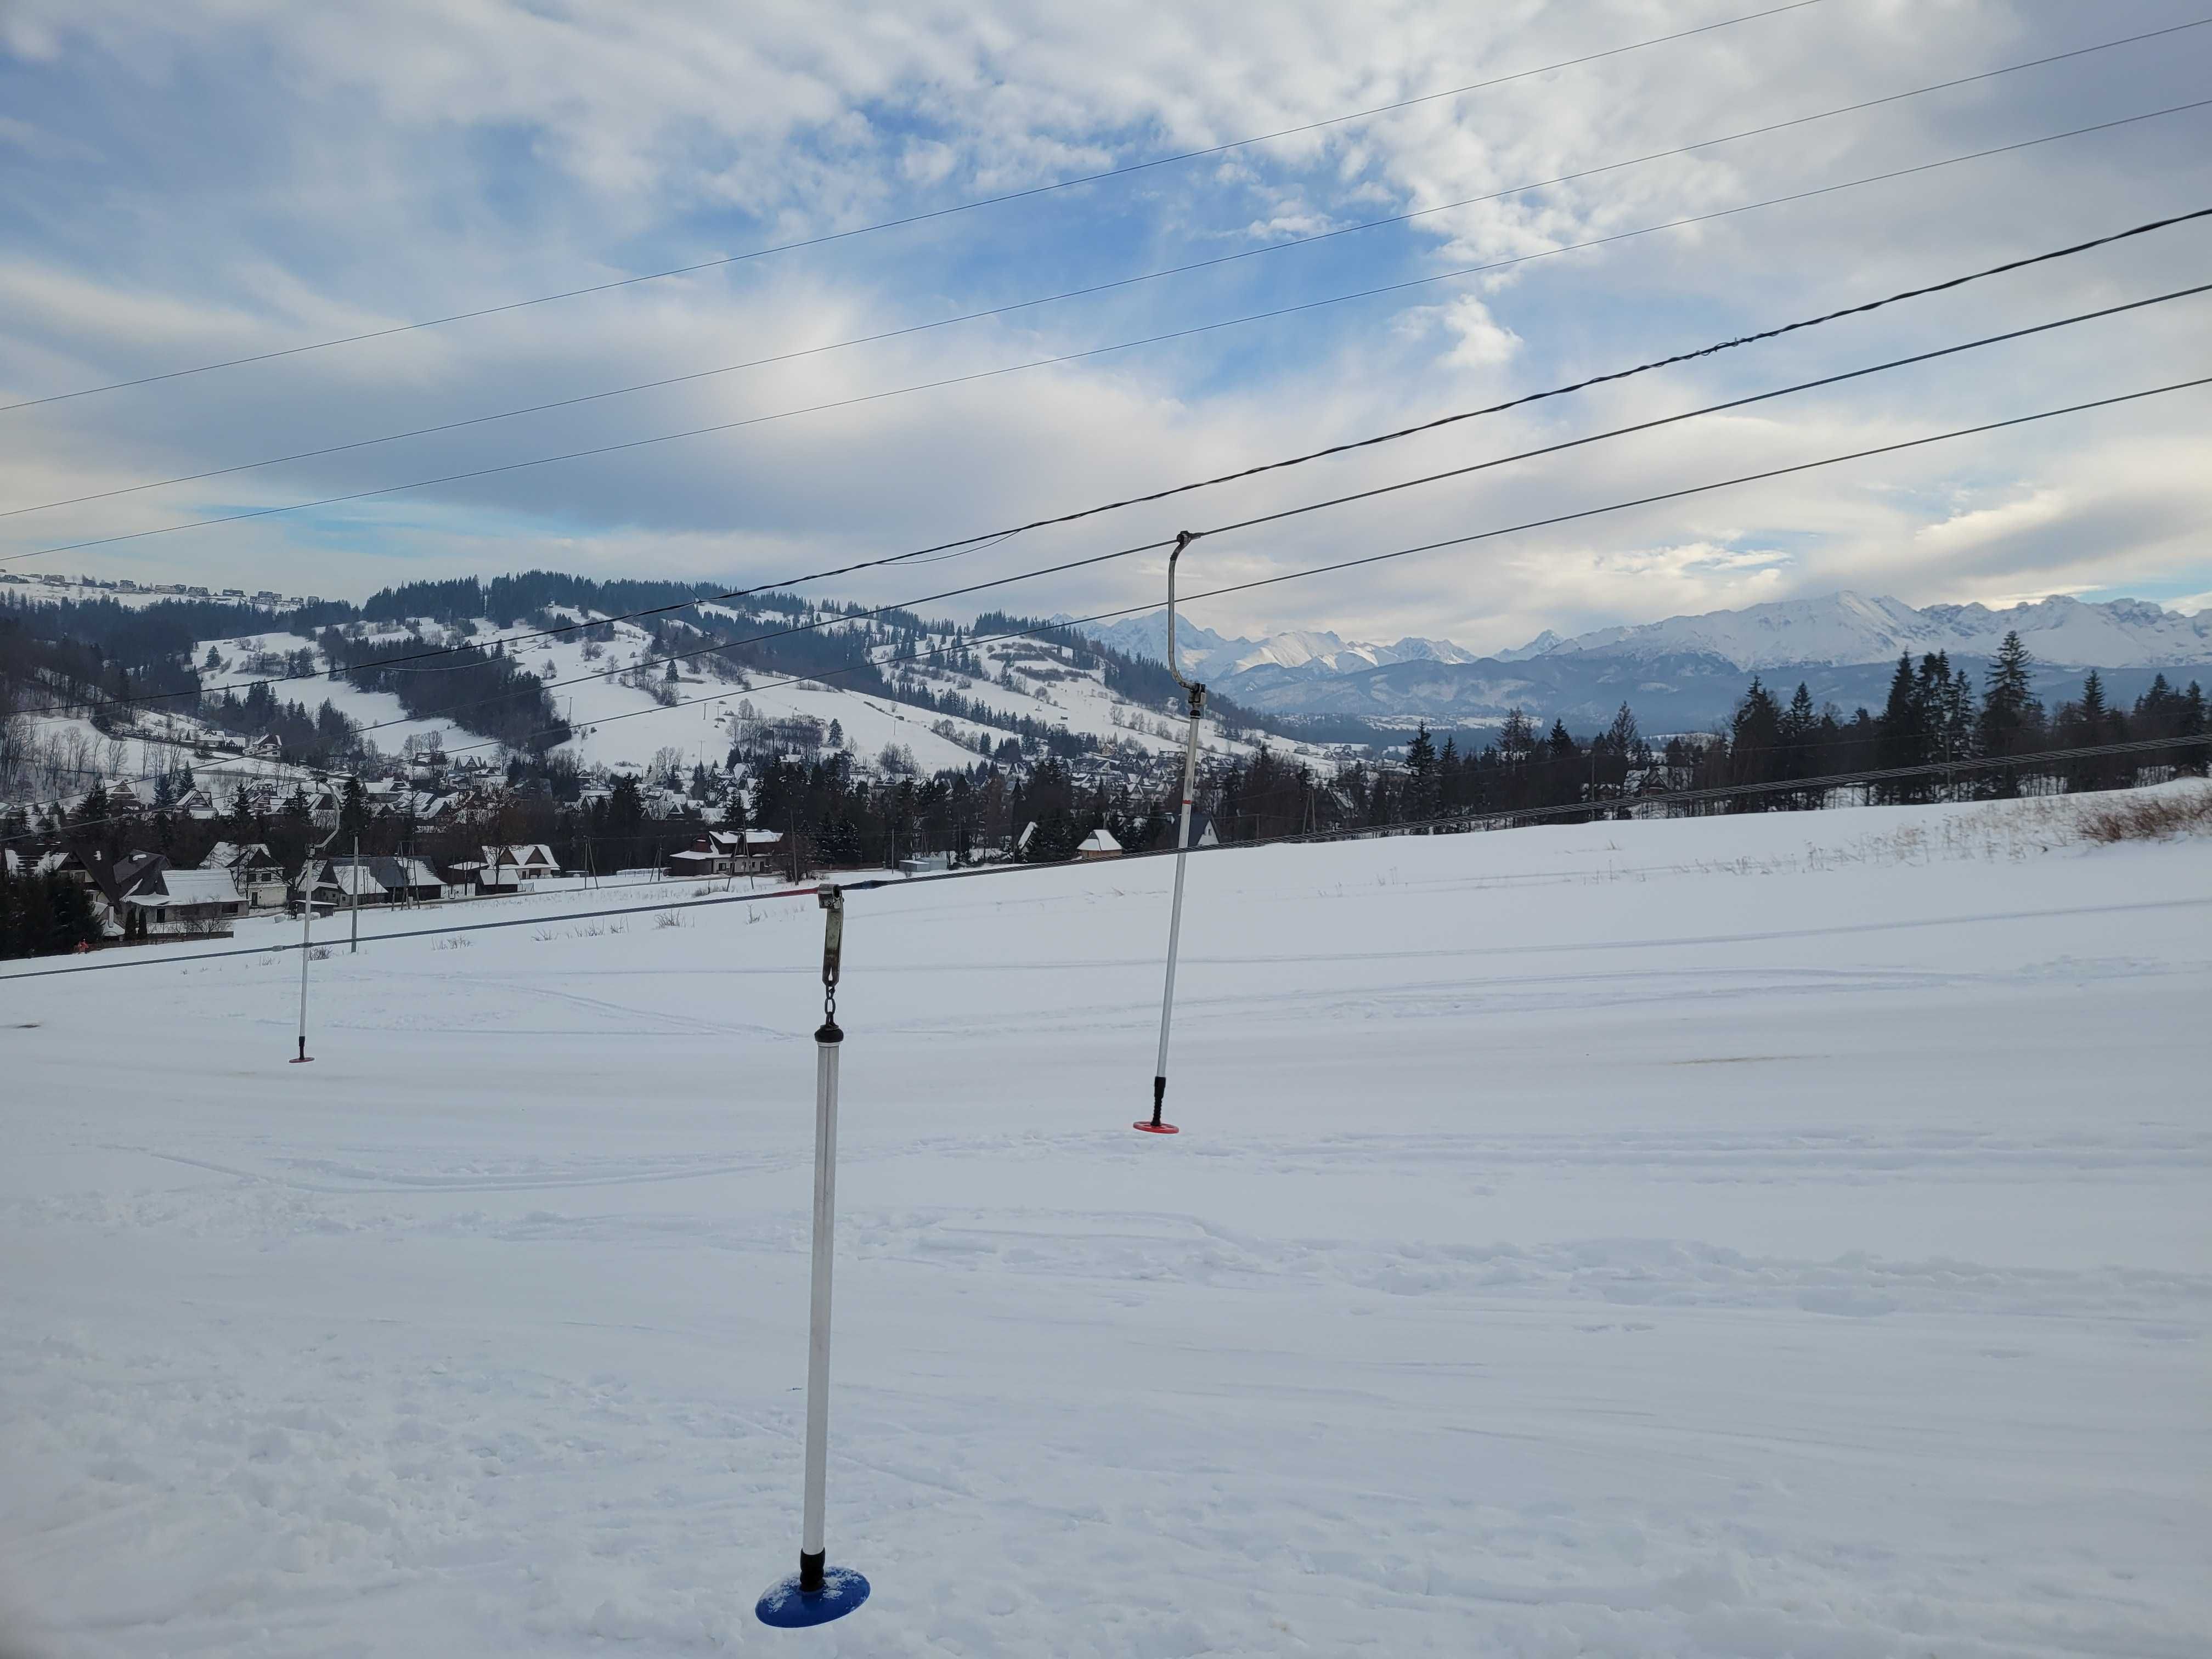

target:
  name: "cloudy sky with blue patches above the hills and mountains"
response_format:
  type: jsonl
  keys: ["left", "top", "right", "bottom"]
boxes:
{"left": 0, "top": 0, "right": 2212, "bottom": 648}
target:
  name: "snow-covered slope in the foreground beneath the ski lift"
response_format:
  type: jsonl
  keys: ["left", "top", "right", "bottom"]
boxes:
{"left": 0, "top": 787, "right": 2212, "bottom": 1659}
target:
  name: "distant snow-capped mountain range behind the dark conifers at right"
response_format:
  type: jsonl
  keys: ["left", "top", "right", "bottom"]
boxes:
{"left": 1062, "top": 593, "right": 2212, "bottom": 725}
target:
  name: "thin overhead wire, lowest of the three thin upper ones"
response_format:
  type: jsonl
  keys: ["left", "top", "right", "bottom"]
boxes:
{"left": 0, "top": 97, "right": 2212, "bottom": 579}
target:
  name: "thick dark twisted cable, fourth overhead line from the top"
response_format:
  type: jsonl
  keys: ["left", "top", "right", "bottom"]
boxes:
{"left": 18, "top": 208, "right": 2212, "bottom": 714}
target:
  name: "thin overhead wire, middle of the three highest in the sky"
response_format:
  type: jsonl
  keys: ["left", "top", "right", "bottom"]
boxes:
{"left": 0, "top": 18, "right": 2212, "bottom": 517}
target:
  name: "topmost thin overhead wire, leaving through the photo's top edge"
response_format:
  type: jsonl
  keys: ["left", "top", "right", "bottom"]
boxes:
{"left": 0, "top": 0, "right": 1822, "bottom": 414}
